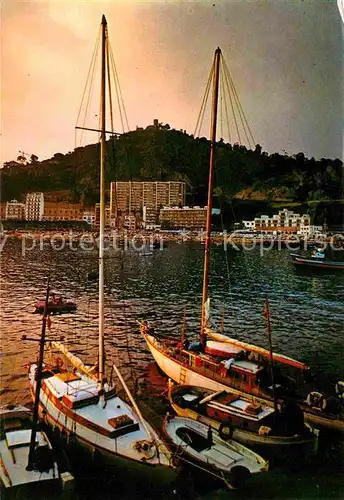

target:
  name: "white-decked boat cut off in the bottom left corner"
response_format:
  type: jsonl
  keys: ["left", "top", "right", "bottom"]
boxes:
{"left": 0, "top": 405, "right": 74, "bottom": 498}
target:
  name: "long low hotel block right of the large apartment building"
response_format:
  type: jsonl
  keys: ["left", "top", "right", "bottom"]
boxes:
{"left": 159, "top": 206, "right": 207, "bottom": 231}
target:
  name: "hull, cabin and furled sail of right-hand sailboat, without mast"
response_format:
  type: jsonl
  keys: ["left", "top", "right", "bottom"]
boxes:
{"left": 140, "top": 322, "right": 344, "bottom": 432}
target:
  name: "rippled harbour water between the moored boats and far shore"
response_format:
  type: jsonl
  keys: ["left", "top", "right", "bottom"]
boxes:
{"left": 1, "top": 240, "right": 344, "bottom": 498}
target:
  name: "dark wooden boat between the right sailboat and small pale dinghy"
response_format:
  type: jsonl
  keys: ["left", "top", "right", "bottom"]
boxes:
{"left": 169, "top": 384, "right": 319, "bottom": 453}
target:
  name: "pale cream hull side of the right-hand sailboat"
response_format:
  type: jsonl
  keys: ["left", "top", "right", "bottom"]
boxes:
{"left": 143, "top": 333, "right": 344, "bottom": 432}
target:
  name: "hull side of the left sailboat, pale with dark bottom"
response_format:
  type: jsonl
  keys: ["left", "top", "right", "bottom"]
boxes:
{"left": 29, "top": 365, "right": 176, "bottom": 488}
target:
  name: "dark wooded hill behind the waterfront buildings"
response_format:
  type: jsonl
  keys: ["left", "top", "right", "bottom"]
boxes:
{"left": 1, "top": 124, "right": 343, "bottom": 224}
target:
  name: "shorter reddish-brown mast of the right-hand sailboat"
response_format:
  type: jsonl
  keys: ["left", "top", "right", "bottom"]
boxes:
{"left": 201, "top": 47, "right": 221, "bottom": 343}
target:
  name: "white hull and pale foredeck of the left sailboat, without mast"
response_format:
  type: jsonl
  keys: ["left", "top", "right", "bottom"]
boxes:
{"left": 29, "top": 365, "right": 175, "bottom": 483}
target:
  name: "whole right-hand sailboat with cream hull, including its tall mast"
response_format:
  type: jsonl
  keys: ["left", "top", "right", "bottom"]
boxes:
{"left": 139, "top": 48, "right": 344, "bottom": 431}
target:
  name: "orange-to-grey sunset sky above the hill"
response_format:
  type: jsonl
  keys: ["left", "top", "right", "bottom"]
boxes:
{"left": 1, "top": 0, "right": 343, "bottom": 161}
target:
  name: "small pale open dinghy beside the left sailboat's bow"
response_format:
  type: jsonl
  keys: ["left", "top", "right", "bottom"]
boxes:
{"left": 163, "top": 415, "right": 269, "bottom": 487}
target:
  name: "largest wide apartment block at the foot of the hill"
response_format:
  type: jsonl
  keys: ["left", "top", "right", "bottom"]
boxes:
{"left": 110, "top": 181, "right": 186, "bottom": 217}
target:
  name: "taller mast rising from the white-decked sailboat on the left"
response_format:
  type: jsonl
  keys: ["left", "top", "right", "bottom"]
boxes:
{"left": 99, "top": 15, "right": 107, "bottom": 391}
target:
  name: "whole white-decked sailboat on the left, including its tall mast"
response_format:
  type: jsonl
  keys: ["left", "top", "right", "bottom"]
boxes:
{"left": 29, "top": 16, "right": 175, "bottom": 485}
